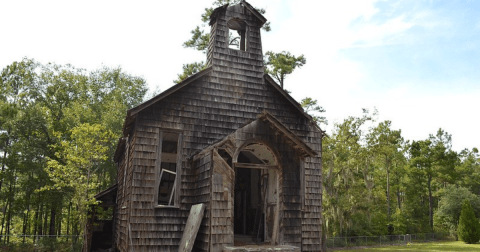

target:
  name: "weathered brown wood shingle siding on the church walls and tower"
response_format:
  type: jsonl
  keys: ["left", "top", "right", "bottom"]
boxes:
{"left": 116, "top": 0, "right": 321, "bottom": 251}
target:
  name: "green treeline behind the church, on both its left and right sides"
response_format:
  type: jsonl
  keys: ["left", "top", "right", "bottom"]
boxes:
{"left": 0, "top": 59, "right": 480, "bottom": 244}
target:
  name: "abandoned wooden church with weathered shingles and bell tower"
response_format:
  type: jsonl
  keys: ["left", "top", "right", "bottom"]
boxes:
{"left": 90, "top": 1, "right": 322, "bottom": 252}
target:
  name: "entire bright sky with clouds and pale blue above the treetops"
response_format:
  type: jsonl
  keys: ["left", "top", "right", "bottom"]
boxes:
{"left": 0, "top": 0, "right": 480, "bottom": 151}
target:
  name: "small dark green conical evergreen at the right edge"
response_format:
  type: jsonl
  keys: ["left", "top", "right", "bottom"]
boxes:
{"left": 458, "top": 200, "right": 480, "bottom": 244}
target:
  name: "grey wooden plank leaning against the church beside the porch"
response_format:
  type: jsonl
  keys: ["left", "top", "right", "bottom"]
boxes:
{"left": 178, "top": 204, "right": 205, "bottom": 252}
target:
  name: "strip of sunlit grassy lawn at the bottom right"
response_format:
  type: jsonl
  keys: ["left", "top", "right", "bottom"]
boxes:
{"left": 338, "top": 241, "right": 480, "bottom": 252}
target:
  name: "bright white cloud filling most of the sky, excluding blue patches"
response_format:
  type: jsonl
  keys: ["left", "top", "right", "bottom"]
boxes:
{"left": 0, "top": 0, "right": 480, "bottom": 152}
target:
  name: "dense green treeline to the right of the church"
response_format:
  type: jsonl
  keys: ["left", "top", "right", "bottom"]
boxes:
{"left": 323, "top": 111, "right": 480, "bottom": 237}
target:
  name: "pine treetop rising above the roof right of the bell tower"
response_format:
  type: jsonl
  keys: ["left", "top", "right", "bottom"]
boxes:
{"left": 264, "top": 51, "right": 307, "bottom": 88}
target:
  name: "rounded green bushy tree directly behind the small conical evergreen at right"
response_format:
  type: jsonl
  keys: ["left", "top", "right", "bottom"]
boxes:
{"left": 435, "top": 185, "right": 480, "bottom": 240}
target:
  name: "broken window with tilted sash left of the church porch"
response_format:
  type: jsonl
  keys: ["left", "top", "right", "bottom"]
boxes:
{"left": 155, "top": 132, "right": 181, "bottom": 206}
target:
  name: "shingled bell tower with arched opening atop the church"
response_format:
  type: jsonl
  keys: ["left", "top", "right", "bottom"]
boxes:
{"left": 207, "top": 1, "right": 267, "bottom": 87}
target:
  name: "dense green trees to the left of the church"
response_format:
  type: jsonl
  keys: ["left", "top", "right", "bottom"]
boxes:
{"left": 0, "top": 59, "right": 146, "bottom": 244}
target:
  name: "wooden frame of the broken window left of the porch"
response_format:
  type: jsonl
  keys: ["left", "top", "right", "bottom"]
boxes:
{"left": 153, "top": 128, "right": 183, "bottom": 208}
